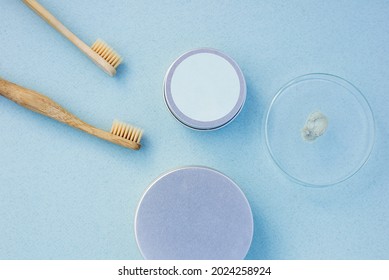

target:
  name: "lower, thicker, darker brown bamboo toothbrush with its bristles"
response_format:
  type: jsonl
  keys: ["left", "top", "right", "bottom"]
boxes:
{"left": 0, "top": 78, "right": 143, "bottom": 150}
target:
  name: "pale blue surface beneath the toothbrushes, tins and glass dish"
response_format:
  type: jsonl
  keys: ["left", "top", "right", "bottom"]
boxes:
{"left": 0, "top": 0, "right": 389, "bottom": 259}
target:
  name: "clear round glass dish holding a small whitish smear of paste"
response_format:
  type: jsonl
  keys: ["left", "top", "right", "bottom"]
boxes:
{"left": 265, "top": 73, "right": 375, "bottom": 187}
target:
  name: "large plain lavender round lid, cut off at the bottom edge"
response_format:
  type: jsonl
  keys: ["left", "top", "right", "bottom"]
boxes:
{"left": 135, "top": 166, "right": 253, "bottom": 260}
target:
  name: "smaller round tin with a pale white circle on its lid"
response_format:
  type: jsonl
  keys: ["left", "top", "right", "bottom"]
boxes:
{"left": 164, "top": 48, "right": 246, "bottom": 130}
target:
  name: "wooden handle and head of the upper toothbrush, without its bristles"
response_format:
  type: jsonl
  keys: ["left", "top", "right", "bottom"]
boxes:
{"left": 23, "top": 0, "right": 116, "bottom": 76}
